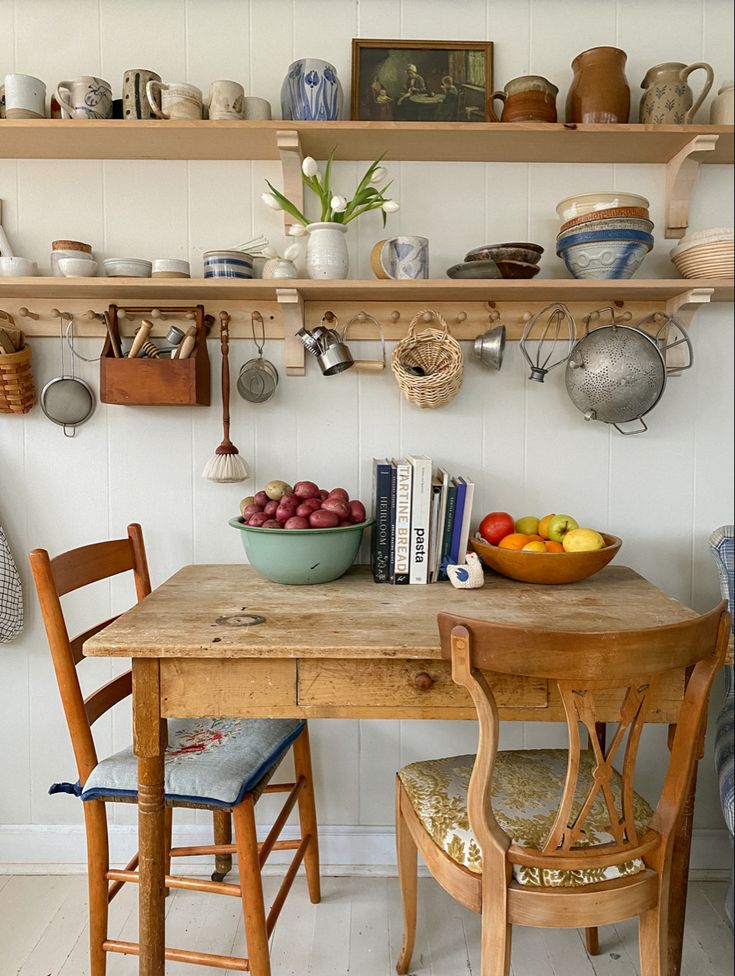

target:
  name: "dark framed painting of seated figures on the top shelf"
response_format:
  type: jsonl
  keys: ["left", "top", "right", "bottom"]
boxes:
{"left": 352, "top": 37, "right": 493, "bottom": 122}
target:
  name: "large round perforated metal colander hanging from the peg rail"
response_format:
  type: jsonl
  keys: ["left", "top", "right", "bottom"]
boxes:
{"left": 566, "top": 314, "right": 694, "bottom": 434}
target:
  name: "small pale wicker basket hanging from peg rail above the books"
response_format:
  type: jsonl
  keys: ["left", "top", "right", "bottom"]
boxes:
{"left": 391, "top": 309, "right": 464, "bottom": 408}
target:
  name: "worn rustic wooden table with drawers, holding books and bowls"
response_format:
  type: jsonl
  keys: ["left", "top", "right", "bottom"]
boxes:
{"left": 84, "top": 565, "right": 708, "bottom": 976}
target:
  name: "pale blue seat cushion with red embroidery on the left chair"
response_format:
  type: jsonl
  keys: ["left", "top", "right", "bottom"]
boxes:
{"left": 50, "top": 718, "right": 306, "bottom": 807}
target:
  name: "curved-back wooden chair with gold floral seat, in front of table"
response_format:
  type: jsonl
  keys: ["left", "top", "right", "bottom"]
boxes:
{"left": 396, "top": 601, "right": 730, "bottom": 976}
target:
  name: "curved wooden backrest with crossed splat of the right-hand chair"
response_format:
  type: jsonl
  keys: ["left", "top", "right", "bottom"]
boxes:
{"left": 438, "top": 601, "right": 730, "bottom": 870}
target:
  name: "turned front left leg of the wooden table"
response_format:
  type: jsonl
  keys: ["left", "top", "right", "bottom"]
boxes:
{"left": 133, "top": 658, "right": 166, "bottom": 976}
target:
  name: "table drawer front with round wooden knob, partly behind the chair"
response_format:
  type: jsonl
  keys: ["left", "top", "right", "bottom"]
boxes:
{"left": 298, "top": 659, "right": 547, "bottom": 708}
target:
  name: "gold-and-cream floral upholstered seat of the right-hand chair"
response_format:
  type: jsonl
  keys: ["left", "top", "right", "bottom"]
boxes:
{"left": 398, "top": 749, "right": 653, "bottom": 887}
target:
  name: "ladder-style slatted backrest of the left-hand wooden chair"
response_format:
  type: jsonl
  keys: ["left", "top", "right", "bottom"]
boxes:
{"left": 29, "top": 524, "right": 151, "bottom": 785}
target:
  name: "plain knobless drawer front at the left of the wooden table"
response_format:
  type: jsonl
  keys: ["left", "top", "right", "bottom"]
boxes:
{"left": 161, "top": 658, "right": 296, "bottom": 718}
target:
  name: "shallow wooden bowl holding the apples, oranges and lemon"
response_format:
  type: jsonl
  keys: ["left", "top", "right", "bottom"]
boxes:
{"left": 470, "top": 532, "right": 623, "bottom": 583}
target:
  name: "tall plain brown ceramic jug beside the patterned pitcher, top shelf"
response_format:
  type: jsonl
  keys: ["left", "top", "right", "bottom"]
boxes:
{"left": 566, "top": 47, "right": 630, "bottom": 122}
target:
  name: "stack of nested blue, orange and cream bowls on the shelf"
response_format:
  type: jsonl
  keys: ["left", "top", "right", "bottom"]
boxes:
{"left": 556, "top": 191, "right": 653, "bottom": 279}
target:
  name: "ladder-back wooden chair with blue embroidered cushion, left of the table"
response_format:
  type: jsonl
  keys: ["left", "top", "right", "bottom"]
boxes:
{"left": 30, "top": 525, "right": 320, "bottom": 976}
